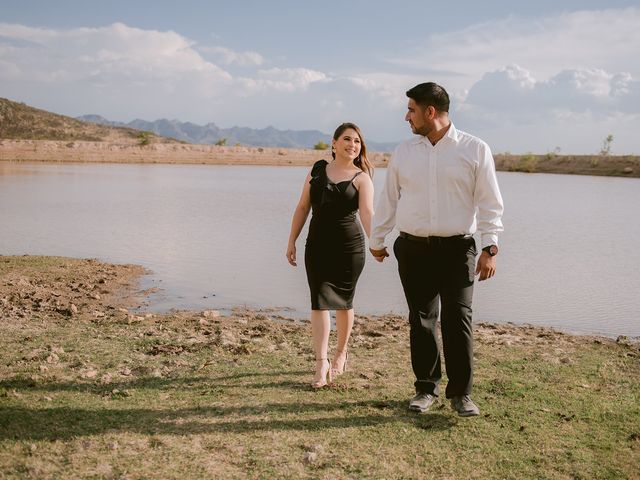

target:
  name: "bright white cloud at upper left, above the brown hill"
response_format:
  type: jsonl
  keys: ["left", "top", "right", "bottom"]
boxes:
{"left": 0, "top": 23, "right": 231, "bottom": 86}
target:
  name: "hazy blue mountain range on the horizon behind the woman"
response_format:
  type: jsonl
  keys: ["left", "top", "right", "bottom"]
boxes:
{"left": 76, "top": 115, "right": 396, "bottom": 152}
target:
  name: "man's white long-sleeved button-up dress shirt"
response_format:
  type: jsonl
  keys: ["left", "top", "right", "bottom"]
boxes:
{"left": 369, "top": 123, "right": 503, "bottom": 250}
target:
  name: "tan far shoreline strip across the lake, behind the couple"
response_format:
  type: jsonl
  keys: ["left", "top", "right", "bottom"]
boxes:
{"left": 0, "top": 140, "right": 640, "bottom": 178}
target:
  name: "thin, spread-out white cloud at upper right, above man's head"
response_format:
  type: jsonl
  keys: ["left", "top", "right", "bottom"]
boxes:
{"left": 389, "top": 7, "right": 640, "bottom": 90}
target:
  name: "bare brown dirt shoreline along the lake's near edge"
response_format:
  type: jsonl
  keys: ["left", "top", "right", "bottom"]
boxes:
{"left": 0, "top": 255, "right": 640, "bottom": 344}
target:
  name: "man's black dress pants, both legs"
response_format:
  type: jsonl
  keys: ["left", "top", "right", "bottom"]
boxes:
{"left": 393, "top": 233, "right": 477, "bottom": 398}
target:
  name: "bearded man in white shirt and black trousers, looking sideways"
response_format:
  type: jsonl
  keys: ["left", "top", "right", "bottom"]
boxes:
{"left": 370, "top": 83, "right": 503, "bottom": 416}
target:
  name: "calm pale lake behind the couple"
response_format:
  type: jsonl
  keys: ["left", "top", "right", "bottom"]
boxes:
{"left": 0, "top": 162, "right": 640, "bottom": 337}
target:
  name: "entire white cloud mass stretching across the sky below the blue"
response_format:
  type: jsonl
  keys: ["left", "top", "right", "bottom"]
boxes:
{"left": 0, "top": 8, "right": 640, "bottom": 153}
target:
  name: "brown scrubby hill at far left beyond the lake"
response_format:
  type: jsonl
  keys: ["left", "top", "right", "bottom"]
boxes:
{"left": 0, "top": 98, "right": 176, "bottom": 145}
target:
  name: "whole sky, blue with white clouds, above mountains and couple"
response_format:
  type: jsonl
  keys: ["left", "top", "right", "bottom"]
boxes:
{"left": 0, "top": 0, "right": 640, "bottom": 155}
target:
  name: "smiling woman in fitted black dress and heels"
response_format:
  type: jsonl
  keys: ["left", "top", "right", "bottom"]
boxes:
{"left": 287, "top": 123, "right": 373, "bottom": 388}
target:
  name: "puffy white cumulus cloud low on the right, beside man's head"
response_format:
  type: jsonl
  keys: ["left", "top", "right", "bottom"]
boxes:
{"left": 454, "top": 65, "right": 640, "bottom": 153}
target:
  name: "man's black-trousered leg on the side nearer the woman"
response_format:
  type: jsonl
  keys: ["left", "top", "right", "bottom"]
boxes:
{"left": 393, "top": 237, "right": 442, "bottom": 396}
